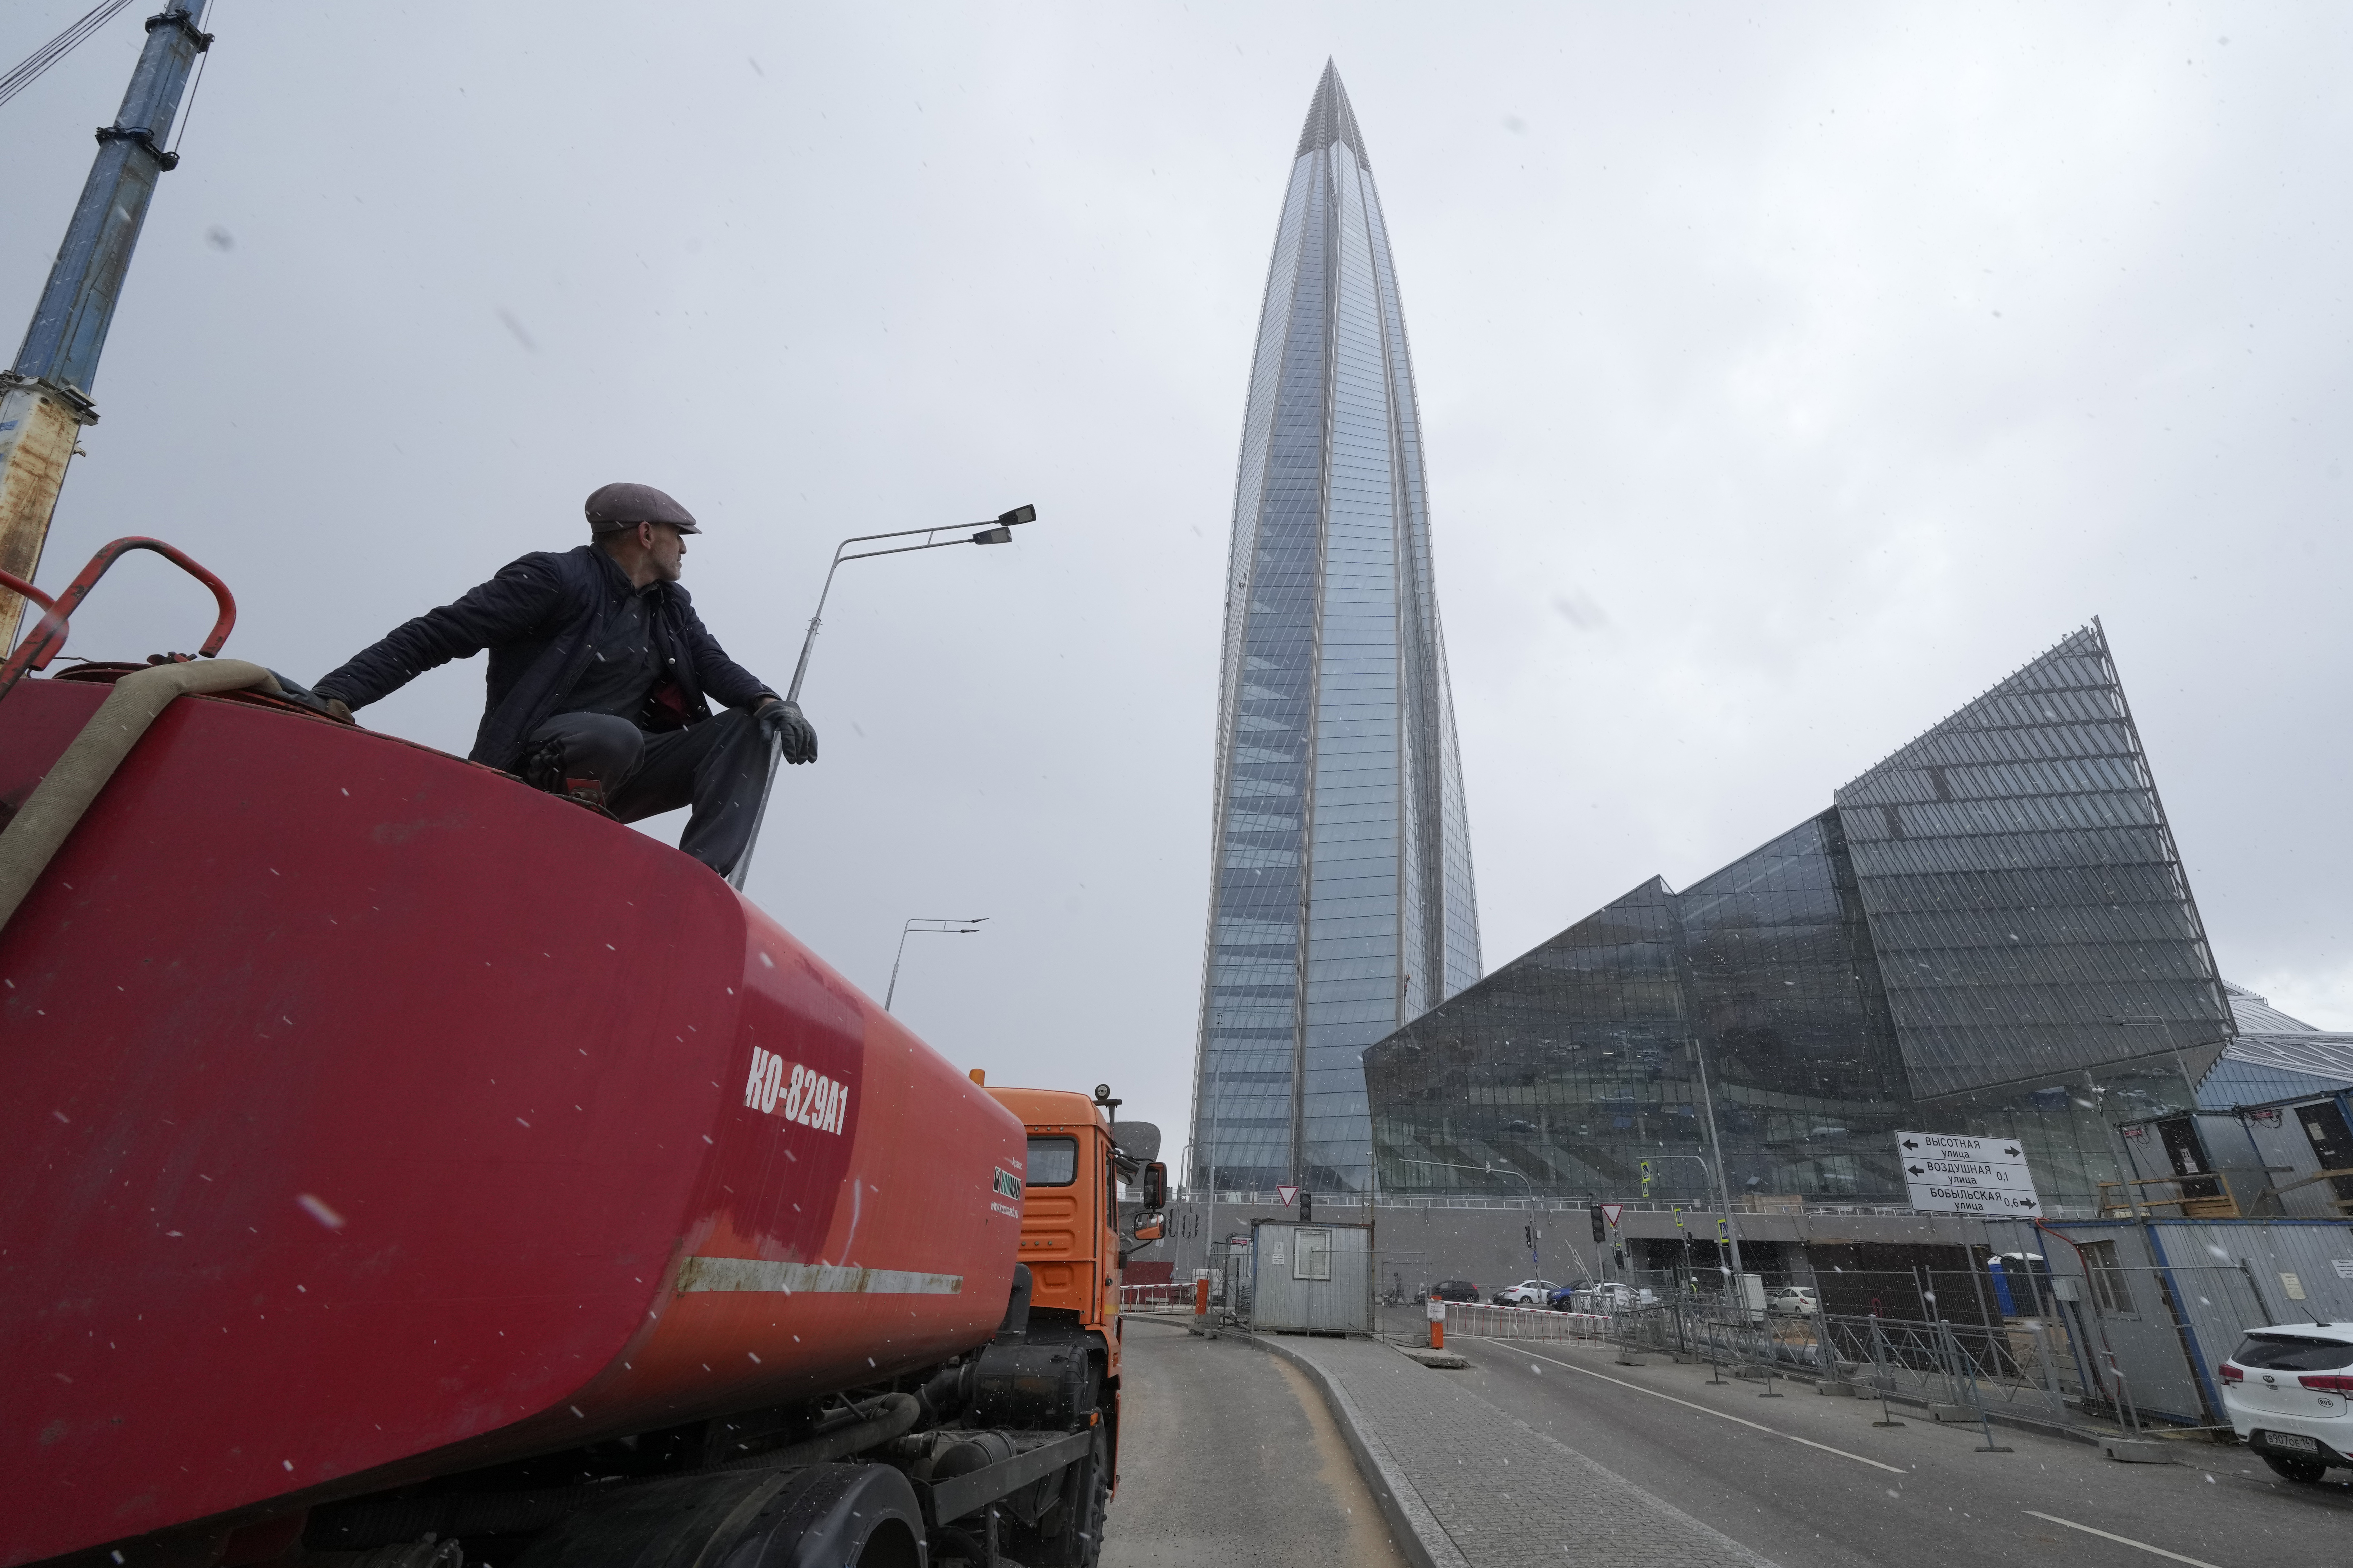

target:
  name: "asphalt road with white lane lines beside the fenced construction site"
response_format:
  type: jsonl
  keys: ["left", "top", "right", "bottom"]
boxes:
{"left": 1447, "top": 1337, "right": 2353, "bottom": 1568}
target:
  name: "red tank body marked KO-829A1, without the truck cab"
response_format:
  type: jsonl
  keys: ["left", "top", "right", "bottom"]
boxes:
{"left": 0, "top": 665, "right": 1045, "bottom": 1566}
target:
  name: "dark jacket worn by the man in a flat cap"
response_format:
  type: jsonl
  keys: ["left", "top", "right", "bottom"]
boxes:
{"left": 315, "top": 545, "right": 774, "bottom": 769}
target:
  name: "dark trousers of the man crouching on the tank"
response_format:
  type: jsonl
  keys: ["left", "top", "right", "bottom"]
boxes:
{"left": 532, "top": 708, "right": 767, "bottom": 877}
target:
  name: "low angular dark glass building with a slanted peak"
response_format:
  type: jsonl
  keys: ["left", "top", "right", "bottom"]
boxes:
{"left": 1367, "top": 621, "right": 2233, "bottom": 1211}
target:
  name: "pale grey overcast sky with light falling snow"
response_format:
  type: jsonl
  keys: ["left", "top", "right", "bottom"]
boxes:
{"left": 0, "top": 0, "right": 2353, "bottom": 1161}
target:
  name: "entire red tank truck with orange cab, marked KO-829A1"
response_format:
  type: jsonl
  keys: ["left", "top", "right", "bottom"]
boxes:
{"left": 0, "top": 541, "right": 1165, "bottom": 1568}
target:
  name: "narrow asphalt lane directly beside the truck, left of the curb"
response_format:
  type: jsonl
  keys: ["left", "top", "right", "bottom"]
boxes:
{"left": 1104, "top": 1316, "right": 1402, "bottom": 1568}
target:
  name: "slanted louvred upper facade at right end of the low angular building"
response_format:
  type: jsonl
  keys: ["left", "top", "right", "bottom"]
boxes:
{"left": 1835, "top": 625, "right": 2231, "bottom": 1096}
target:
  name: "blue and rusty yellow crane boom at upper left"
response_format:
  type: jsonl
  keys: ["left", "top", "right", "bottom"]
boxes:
{"left": 0, "top": 0, "right": 212, "bottom": 649}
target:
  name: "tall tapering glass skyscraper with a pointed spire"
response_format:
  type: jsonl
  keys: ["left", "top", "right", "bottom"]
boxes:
{"left": 1188, "top": 66, "right": 1480, "bottom": 1194}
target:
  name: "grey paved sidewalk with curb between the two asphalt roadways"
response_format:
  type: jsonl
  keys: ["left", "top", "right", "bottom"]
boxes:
{"left": 1257, "top": 1335, "right": 1774, "bottom": 1568}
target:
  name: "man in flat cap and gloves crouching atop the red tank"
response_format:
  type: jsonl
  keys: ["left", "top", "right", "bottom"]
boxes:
{"left": 315, "top": 484, "right": 816, "bottom": 877}
